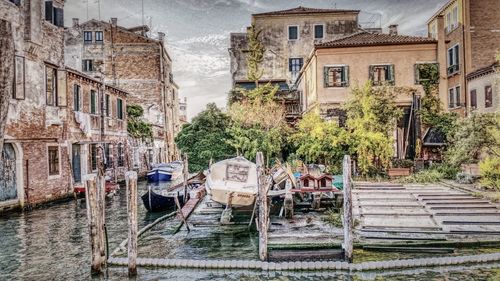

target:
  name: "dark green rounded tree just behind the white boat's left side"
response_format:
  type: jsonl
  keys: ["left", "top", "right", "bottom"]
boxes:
{"left": 175, "top": 103, "right": 235, "bottom": 172}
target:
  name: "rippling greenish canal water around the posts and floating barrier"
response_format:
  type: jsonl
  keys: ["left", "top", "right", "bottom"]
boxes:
{"left": 0, "top": 182, "right": 500, "bottom": 281}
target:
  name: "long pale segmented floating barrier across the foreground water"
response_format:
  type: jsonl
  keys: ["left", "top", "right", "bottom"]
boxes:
{"left": 108, "top": 250, "right": 500, "bottom": 271}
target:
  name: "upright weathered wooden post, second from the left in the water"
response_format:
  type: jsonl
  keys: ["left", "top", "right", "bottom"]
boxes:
{"left": 125, "top": 171, "right": 137, "bottom": 276}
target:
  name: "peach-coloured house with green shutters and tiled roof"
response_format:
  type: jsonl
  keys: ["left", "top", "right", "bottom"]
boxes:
{"left": 296, "top": 29, "right": 438, "bottom": 158}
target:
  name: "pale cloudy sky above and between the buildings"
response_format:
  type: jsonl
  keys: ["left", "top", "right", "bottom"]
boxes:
{"left": 65, "top": 0, "right": 447, "bottom": 119}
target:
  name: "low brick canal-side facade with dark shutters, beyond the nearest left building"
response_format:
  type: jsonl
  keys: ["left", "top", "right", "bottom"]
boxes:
{"left": 66, "top": 68, "right": 132, "bottom": 186}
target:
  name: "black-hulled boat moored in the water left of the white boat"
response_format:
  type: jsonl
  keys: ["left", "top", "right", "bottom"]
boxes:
{"left": 141, "top": 173, "right": 205, "bottom": 212}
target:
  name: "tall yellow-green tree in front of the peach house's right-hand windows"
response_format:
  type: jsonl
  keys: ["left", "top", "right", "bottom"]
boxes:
{"left": 344, "top": 83, "right": 408, "bottom": 176}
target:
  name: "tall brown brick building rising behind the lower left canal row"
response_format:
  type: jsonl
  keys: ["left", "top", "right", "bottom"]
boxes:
{"left": 65, "top": 18, "right": 179, "bottom": 166}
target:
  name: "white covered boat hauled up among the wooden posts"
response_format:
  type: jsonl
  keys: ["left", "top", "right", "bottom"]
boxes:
{"left": 205, "top": 156, "right": 257, "bottom": 207}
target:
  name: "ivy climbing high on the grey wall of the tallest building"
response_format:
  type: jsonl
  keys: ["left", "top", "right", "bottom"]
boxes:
{"left": 247, "top": 24, "right": 265, "bottom": 84}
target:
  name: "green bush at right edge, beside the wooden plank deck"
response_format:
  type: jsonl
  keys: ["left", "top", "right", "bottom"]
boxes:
{"left": 445, "top": 113, "right": 500, "bottom": 167}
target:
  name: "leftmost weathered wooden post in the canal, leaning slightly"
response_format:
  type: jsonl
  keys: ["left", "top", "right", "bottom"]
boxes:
{"left": 84, "top": 174, "right": 102, "bottom": 275}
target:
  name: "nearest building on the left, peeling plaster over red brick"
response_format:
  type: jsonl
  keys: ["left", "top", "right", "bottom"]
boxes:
{"left": 0, "top": 0, "right": 72, "bottom": 209}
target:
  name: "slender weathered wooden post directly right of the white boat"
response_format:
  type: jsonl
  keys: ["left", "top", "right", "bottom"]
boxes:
{"left": 256, "top": 152, "right": 269, "bottom": 261}
